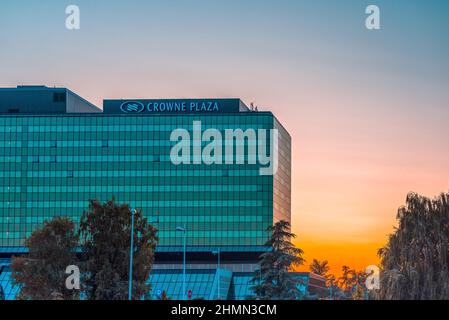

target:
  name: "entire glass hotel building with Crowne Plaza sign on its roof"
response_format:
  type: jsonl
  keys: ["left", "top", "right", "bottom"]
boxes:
{"left": 0, "top": 86, "right": 291, "bottom": 299}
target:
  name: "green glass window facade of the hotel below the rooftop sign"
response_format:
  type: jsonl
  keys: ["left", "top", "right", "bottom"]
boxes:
{"left": 0, "top": 112, "right": 291, "bottom": 248}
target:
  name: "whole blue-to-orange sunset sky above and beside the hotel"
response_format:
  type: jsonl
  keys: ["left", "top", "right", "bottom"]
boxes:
{"left": 0, "top": 0, "right": 449, "bottom": 273}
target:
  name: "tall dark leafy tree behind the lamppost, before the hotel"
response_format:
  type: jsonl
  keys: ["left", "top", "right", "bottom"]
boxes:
{"left": 80, "top": 199, "right": 158, "bottom": 300}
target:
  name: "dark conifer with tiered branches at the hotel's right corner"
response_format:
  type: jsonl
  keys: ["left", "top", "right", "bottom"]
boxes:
{"left": 248, "top": 220, "right": 304, "bottom": 300}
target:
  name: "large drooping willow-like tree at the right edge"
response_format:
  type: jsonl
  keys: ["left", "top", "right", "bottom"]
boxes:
{"left": 374, "top": 193, "right": 449, "bottom": 300}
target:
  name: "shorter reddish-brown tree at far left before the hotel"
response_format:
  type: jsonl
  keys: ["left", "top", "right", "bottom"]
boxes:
{"left": 11, "top": 218, "right": 79, "bottom": 300}
